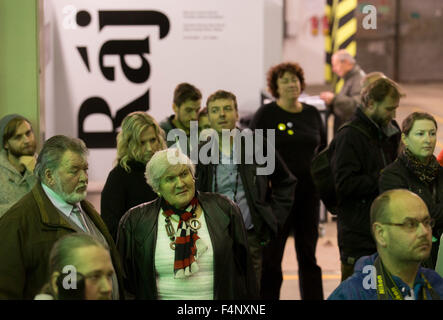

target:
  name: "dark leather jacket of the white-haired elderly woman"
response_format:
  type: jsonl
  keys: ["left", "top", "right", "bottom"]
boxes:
{"left": 117, "top": 193, "right": 258, "bottom": 300}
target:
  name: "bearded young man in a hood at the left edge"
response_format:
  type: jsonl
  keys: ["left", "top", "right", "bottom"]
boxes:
{"left": 0, "top": 114, "right": 36, "bottom": 217}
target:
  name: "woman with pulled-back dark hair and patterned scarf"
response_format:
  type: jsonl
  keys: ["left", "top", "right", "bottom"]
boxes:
{"left": 379, "top": 112, "right": 443, "bottom": 269}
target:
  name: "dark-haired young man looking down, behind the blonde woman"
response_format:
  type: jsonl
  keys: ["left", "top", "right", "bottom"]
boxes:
{"left": 160, "top": 83, "right": 202, "bottom": 156}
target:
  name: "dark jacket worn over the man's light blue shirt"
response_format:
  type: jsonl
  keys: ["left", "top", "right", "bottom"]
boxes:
{"left": 196, "top": 131, "right": 297, "bottom": 243}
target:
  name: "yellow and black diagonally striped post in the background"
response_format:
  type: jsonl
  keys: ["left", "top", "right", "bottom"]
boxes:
{"left": 325, "top": 0, "right": 357, "bottom": 92}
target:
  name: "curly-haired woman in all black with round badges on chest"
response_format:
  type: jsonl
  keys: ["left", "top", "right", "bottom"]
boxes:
{"left": 250, "top": 63, "right": 327, "bottom": 300}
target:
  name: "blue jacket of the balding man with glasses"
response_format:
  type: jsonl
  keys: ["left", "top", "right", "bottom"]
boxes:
{"left": 328, "top": 254, "right": 443, "bottom": 300}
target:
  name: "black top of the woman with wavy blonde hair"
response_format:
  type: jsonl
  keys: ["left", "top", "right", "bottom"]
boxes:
{"left": 100, "top": 161, "right": 157, "bottom": 240}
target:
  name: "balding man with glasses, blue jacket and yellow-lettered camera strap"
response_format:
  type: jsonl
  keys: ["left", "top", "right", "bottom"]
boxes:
{"left": 328, "top": 189, "right": 443, "bottom": 300}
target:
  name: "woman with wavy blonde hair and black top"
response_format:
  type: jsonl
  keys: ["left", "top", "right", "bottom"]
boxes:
{"left": 101, "top": 111, "right": 166, "bottom": 240}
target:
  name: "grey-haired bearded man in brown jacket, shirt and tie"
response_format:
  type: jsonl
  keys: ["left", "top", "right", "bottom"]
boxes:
{"left": 0, "top": 135, "right": 123, "bottom": 299}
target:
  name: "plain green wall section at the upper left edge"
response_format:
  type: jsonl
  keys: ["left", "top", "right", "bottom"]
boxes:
{"left": 0, "top": 0, "right": 40, "bottom": 137}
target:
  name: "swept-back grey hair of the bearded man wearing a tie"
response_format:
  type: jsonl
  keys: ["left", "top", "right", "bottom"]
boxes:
{"left": 34, "top": 135, "right": 88, "bottom": 181}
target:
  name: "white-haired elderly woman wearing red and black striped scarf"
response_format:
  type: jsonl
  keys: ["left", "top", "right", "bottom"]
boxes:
{"left": 117, "top": 149, "right": 258, "bottom": 300}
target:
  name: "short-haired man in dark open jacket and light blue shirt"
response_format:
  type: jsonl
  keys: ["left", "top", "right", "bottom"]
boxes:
{"left": 196, "top": 90, "right": 296, "bottom": 290}
